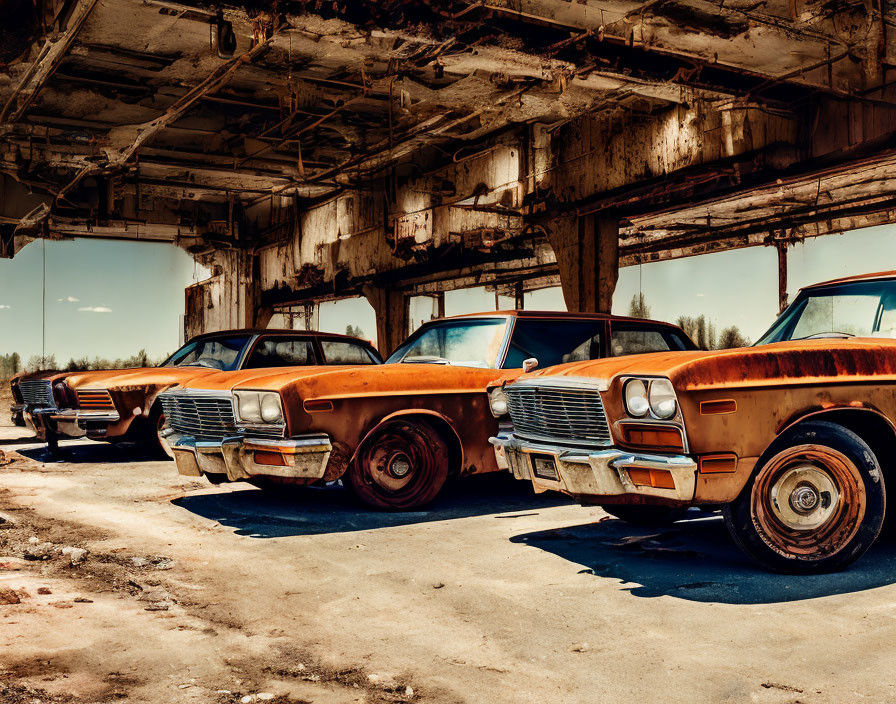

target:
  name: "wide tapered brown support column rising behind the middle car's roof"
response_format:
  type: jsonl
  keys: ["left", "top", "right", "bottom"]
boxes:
{"left": 550, "top": 215, "right": 619, "bottom": 313}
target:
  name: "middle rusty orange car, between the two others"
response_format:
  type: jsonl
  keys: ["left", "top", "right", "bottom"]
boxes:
{"left": 160, "top": 311, "right": 694, "bottom": 510}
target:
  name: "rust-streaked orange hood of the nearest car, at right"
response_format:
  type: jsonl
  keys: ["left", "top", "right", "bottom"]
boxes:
{"left": 521, "top": 338, "right": 896, "bottom": 390}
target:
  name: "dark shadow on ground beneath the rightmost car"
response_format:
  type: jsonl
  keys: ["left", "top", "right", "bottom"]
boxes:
{"left": 511, "top": 511, "right": 896, "bottom": 604}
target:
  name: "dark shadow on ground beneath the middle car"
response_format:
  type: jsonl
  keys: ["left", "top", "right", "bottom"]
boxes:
{"left": 172, "top": 472, "right": 570, "bottom": 538}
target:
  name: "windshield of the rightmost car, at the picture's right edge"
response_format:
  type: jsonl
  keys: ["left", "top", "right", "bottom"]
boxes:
{"left": 756, "top": 281, "right": 896, "bottom": 345}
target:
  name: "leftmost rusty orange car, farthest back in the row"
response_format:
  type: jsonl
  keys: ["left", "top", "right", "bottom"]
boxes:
{"left": 12, "top": 329, "right": 382, "bottom": 456}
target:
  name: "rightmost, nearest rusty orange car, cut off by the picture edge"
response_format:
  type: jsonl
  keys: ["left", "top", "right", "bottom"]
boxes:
{"left": 489, "top": 272, "right": 896, "bottom": 573}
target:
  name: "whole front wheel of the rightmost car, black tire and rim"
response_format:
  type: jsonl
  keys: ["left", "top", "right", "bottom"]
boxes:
{"left": 723, "top": 421, "right": 887, "bottom": 574}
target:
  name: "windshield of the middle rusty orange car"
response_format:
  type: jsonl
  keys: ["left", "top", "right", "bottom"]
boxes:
{"left": 386, "top": 318, "right": 507, "bottom": 369}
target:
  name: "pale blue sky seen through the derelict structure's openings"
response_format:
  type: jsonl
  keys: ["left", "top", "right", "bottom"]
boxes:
{"left": 0, "top": 225, "right": 896, "bottom": 363}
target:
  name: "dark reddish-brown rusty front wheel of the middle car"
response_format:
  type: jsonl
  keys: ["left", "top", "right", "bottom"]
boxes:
{"left": 346, "top": 420, "right": 449, "bottom": 511}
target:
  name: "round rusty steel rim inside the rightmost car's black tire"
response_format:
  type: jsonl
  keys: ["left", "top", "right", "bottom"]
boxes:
{"left": 750, "top": 445, "right": 866, "bottom": 560}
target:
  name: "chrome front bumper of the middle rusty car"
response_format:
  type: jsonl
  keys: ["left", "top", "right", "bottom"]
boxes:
{"left": 162, "top": 429, "right": 333, "bottom": 481}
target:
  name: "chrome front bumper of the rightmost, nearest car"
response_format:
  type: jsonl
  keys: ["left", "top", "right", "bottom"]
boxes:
{"left": 489, "top": 432, "right": 697, "bottom": 502}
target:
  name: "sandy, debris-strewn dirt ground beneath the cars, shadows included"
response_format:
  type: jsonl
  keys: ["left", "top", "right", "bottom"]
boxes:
{"left": 0, "top": 394, "right": 896, "bottom": 704}
